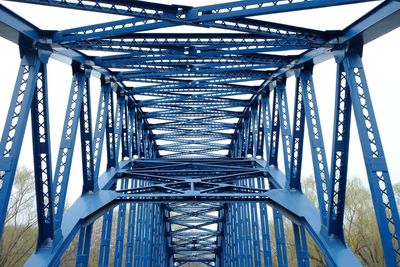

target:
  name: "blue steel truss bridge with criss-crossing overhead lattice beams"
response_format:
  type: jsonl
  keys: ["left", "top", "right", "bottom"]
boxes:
{"left": 0, "top": 0, "right": 400, "bottom": 267}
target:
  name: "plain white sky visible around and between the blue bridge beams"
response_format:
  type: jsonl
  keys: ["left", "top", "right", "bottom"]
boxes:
{"left": 0, "top": 1, "right": 400, "bottom": 205}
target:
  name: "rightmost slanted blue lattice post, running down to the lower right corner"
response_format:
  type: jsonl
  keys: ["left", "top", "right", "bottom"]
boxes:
{"left": 343, "top": 50, "right": 400, "bottom": 266}
